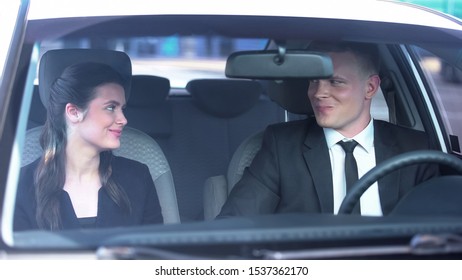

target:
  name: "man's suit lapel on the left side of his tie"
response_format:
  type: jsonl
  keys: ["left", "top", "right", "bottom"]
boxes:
{"left": 303, "top": 122, "right": 334, "bottom": 213}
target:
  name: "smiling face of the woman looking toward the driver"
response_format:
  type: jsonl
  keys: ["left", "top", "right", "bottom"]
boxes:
{"left": 75, "top": 83, "right": 127, "bottom": 151}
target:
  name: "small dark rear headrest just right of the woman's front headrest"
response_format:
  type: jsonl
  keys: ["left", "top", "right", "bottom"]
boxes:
{"left": 127, "top": 75, "right": 170, "bottom": 107}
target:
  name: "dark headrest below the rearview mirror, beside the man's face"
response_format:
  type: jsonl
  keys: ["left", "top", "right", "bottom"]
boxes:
{"left": 263, "top": 79, "right": 314, "bottom": 116}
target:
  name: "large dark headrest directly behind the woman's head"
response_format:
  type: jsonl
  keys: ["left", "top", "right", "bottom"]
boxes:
{"left": 39, "top": 49, "right": 132, "bottom": 107}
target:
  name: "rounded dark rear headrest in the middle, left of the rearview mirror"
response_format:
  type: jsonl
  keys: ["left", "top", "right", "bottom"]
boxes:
{"left": 186, "top": 79, "right": 263, "bottom": 118}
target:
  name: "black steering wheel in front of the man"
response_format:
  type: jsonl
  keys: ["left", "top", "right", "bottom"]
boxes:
{"left": 338, "top": 150, "right": 462, "bottom": 214}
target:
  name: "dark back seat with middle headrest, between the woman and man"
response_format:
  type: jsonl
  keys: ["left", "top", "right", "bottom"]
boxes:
{"left": 167, "top": 78, "right": 284, "bottom": 222}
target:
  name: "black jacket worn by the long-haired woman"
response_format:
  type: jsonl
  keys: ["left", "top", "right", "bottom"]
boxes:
{"left": 14, "top": 156, "right": 163, "bottom": 230}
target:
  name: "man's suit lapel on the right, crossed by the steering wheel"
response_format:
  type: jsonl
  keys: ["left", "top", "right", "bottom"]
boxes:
{"left": 374, "top": 121, "right": 401, "bottom": 214}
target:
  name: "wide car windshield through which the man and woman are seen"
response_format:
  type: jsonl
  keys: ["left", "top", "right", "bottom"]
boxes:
{"left": 0, "top": 1, "right": 462, "bottom": 259}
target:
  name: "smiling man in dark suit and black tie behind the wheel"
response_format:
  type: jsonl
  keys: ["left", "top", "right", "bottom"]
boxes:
{"left": 219, "top": 43, "right": 438, "bottom": 217}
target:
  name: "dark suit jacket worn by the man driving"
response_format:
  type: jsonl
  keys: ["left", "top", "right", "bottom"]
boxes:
{"left": 219, "top": 118, "right": 439, "bottom": 217}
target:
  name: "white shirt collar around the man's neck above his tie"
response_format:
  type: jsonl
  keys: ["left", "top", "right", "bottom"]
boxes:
{"left": 323, "top": 119, "right": 374, "bottom": 153}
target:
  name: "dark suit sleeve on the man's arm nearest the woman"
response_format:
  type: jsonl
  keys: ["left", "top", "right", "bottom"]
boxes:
{"left": 218, "top": 127, "right": 280, "bottom": 218}
